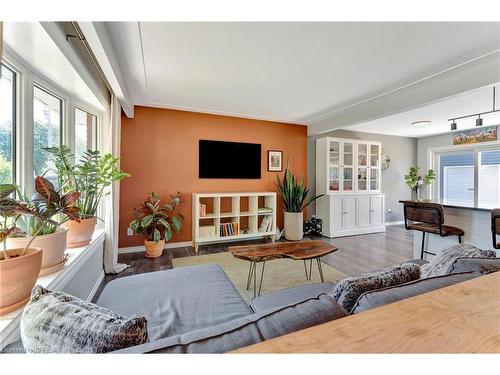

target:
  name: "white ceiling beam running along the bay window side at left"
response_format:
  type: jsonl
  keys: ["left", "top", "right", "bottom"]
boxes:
{"left": 78, "top": 22, "right": 134, "bottom": 118}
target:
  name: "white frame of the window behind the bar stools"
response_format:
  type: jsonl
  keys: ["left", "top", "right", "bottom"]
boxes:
{"left": 427, "top": 140, "right": 500, "bottom": 209}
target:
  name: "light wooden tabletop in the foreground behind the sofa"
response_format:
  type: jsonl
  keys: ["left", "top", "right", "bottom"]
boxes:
{"left": 235, "top": 272, "right": 500, "bottom": 353}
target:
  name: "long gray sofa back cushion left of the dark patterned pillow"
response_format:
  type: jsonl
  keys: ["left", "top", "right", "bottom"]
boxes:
{"left": 111, "top": 294, "right": 346, "bottom": 353}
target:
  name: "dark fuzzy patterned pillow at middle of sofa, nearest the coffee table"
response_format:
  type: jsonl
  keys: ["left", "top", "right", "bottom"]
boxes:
{"left": 331, "top": 263, "right": 420, "bottom": 312}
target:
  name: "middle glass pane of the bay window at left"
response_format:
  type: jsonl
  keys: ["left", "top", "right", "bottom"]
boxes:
{"left": 33, "top": 86, "right": 63, "bottom": 182}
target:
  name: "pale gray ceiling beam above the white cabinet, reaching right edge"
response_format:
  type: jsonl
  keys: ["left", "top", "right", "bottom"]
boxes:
{"left": 308, "top": 51, "right": 500, "bottom": 135}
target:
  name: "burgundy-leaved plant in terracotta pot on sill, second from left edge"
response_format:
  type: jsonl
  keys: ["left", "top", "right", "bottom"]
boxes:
{"left": 6, "top": 176, "right": 80, "bottom": 275}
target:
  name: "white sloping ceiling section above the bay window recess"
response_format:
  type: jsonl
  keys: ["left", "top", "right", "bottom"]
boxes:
{"left": 3, "top": 22, "right": 104, "bottom": 109}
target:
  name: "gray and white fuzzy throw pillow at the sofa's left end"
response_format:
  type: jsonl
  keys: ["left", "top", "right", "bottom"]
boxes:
{"left": 20, "top": 286, "right": 148, "bottom": 353}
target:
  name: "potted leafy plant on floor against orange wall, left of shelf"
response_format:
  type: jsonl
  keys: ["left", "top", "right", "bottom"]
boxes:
{"left": 129, "top": 193, "right": 184, "bottom": 258}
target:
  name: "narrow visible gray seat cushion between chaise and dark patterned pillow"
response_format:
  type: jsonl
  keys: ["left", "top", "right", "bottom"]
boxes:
{"left": 250, "top": 283, "right": 334, "bottom": 312}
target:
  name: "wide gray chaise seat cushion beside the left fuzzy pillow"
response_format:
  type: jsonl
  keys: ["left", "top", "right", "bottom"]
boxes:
{"left": 97, "top": 264, "right": 252, "bottom": 341}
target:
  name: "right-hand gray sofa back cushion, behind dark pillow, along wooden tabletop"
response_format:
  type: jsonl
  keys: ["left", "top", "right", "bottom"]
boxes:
{"left": 351, "top": 272, "right": 480, "bottom": 314}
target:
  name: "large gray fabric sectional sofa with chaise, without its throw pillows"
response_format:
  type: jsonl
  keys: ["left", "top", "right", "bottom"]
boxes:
{"left": 7, "top": 258, "right": 500, "bottom": 353}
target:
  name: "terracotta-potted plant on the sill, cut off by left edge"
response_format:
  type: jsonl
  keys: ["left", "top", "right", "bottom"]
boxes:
{"left": 0, "top": 184, "right": 42, "bottom": 315}
